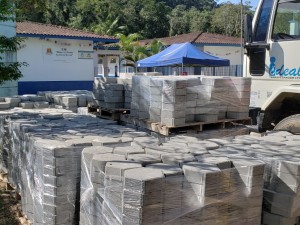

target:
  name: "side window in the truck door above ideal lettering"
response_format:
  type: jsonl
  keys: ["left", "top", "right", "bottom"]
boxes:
{"left": 272, "top": 0, "right": 300, "bottom": 41}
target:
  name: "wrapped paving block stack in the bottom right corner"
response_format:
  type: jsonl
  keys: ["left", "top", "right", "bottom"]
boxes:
{"left": 263, "top": 160, "right": 300, "bottom": 225}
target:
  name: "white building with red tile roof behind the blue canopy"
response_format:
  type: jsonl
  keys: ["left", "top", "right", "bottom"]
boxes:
{"left": 140, "top": 32, "right": 243, "bottom": 76}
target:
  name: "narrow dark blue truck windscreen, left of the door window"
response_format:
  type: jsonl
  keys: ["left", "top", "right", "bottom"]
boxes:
{"left": 254, "top": 0, "right": 273, "bottom": 42}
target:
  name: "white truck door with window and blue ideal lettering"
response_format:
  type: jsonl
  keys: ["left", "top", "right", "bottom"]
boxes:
{"left": 266, "top": 0, "right": 300, "bottom": 81}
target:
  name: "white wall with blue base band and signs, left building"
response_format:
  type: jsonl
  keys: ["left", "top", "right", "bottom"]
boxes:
{"left": 17, "top": 37, "right": 94, "bottom": 94}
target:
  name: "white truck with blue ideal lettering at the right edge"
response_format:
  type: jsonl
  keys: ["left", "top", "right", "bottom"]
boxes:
{"left": 243, "top": 0, "right": 300, "bottom": 133}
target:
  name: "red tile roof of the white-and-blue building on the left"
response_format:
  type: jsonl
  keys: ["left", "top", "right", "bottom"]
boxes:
{"left": 17, "top": 21, "right": 117, "bottom": 42}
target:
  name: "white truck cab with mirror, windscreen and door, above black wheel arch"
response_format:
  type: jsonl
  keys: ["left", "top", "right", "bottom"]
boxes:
{"left": 244, "top": 0, "right": 300, "bottom": 108}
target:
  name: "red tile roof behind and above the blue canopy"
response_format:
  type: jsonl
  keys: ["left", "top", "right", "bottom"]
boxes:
{"left": 139, "top": 32, "right": 241, "bottom": 45}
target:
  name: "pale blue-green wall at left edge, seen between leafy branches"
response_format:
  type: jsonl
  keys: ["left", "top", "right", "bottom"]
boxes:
{"left": 0, "top": 21, "right": 18, "bottom": 97}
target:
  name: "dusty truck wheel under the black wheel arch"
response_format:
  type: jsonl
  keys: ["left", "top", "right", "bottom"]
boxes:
{"left": 274, "top": 114, "right": 300, "bottom": 134}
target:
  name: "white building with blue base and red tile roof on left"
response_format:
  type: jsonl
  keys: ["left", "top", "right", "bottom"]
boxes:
{"left": 17, "top": 22, "right": 117, "bottom": 94}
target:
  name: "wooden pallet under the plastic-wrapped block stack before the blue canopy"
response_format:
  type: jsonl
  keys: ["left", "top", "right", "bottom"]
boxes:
{"left": 121, "top": 115, "right": 251, "bottom": 136}
